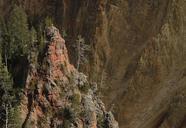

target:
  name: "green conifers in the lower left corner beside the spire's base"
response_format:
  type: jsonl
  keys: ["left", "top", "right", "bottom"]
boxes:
{"left": 0, "top": 55, "right": 19, "bottom": 128}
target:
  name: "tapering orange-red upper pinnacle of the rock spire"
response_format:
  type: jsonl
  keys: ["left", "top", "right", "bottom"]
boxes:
{"left": 47, "top": 27, "right": 75, "bottom": 79}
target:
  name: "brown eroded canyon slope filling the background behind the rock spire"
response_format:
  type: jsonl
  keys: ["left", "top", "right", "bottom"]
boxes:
{"left": 0, "top": 0, "right": 186, "bottom": 128}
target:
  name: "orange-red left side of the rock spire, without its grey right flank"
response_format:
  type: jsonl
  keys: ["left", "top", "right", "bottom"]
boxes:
{"left": 21, "top": 26, "right": 75, "bottom": 127}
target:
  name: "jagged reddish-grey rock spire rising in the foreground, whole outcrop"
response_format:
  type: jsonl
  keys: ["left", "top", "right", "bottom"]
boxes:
{"left": 20, "top": 26, "right": 118, "bottom": 128}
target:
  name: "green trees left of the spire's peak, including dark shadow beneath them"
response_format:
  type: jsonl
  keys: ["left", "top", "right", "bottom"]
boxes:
{"left": 0, "top": 4, "right": 52, "bottom": 88}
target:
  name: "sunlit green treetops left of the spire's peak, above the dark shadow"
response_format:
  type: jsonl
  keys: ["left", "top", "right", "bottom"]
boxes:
{"left": 0, "top": 5, "right": 53, "bottom": 62}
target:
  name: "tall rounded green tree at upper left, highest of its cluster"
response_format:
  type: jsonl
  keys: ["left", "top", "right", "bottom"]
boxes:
{"left": 7, "top": 5, "right": 31, "bottom": 56}
